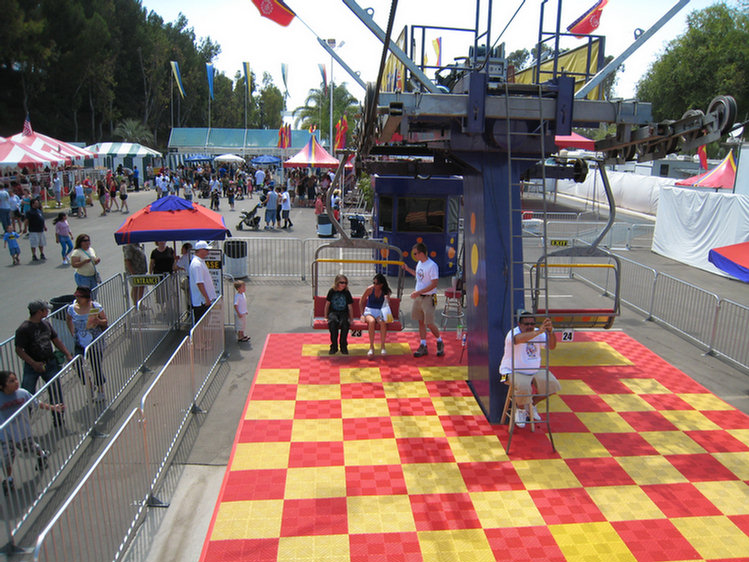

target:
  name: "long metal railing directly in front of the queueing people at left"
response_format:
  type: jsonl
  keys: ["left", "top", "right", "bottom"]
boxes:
{"left": 0, "top": 276, "right": 180, "bottom": 544}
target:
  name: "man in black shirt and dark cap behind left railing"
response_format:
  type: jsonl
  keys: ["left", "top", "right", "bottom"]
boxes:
{"left": 15, "top": 301, "right": 73, "bottom": 426}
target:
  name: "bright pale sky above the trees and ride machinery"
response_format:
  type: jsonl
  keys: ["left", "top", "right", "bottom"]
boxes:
{"left": 141, "top": 0, "right": 730, "bottom": 121}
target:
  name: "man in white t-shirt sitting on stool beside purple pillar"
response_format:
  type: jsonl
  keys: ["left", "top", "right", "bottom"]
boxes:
{"left": 499, "top": 310, "right": 562, "bottom": 427}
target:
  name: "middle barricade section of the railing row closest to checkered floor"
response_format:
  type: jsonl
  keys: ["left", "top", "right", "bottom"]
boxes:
{"left": 140, "top": 337, "right": 193, "bottom": 496}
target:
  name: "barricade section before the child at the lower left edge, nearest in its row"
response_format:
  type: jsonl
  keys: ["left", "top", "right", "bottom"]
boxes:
{"left": 0, "top": 355, "right": 101, "bottom": 544}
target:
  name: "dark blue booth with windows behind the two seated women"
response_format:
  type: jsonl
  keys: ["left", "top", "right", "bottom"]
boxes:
{"left": 372, "top": 175, "right": 463, "bottom": 277}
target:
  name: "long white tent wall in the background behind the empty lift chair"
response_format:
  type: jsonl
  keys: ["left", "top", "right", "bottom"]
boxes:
{"left": 547, "top": 168, "right": 674, "bottom": 215}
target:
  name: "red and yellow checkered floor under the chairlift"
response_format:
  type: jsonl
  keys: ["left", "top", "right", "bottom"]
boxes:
{"left": 201, "top": 332, "right": 749, "bottom": 562}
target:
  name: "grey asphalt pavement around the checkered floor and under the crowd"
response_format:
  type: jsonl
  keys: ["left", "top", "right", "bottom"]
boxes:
{"left": 0, "top": 188, "right": 749, "bottom": 562}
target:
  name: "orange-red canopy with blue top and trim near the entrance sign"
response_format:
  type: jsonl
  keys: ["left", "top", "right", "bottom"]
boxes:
{"left": 114, "top": 195, "right": 231, "bottom": 244}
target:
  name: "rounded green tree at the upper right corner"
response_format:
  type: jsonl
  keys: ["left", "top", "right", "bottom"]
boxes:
{"left": 637, "top": 2, "right": 749, "bottom": 121}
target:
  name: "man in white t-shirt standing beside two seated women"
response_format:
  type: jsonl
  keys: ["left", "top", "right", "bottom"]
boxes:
{"left": 403, "top": 242, "right": 445, "bottom": 357}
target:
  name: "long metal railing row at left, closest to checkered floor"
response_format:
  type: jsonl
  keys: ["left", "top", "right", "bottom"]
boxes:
{"left": 34, "top": 297, "right": 224, "bottom": 562}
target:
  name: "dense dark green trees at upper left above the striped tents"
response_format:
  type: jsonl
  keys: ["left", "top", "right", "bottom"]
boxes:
{"left": 0, "top": 0, "right": 285, "bottom": 146}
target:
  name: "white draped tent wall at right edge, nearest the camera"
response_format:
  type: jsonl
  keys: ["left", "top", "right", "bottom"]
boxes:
{"left": 652, "top": 187, "right": 749, "bottom": 277}
